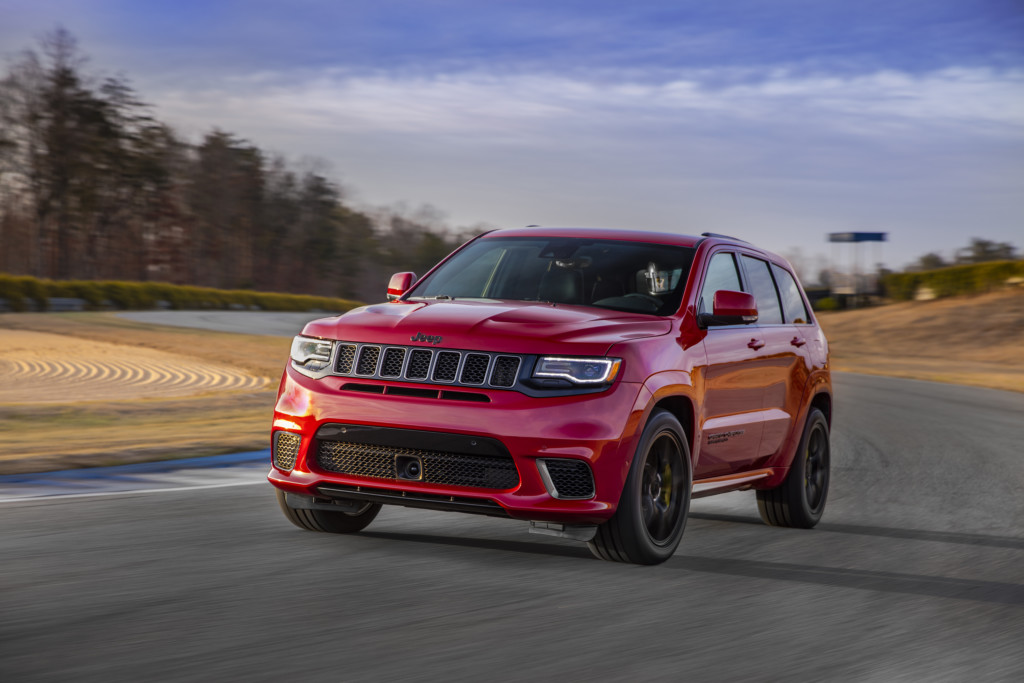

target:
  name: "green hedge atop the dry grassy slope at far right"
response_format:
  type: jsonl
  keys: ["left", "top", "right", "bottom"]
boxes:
{"left": 883, "top": 261, "right": 1024, "bottom": 301}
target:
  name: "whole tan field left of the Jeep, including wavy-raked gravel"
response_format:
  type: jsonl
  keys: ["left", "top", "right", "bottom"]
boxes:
{"left": 0, "top": 313, "right": 290, "bottom": 474}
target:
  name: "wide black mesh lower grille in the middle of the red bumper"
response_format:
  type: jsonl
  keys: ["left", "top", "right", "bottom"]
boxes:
{"left": 316, "top": 441, "right": 519, "bottom": 488}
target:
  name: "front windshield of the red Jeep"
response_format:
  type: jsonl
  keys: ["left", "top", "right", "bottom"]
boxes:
{"left": 409, "top": 238, "right": 694, "bottom": 315}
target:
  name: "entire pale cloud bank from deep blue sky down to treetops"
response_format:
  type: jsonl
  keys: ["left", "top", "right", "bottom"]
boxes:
{"left": 150, "top": 63, "right": 1024, "bottom": 262}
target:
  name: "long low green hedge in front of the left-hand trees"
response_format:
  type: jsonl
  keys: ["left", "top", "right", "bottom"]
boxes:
{"left": 0, "top": 273, "right": 361, "bottom": 312}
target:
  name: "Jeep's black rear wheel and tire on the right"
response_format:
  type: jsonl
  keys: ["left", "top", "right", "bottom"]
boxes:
{"left": 757, "top": 408, "right": 831, "bottom": 528}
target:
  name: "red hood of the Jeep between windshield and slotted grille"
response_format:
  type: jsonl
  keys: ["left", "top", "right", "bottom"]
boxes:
{"left": 303, "top": 300, "right": 672, "bottom": 355}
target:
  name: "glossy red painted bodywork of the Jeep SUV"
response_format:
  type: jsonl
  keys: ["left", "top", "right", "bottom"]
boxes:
{"left": 269, "top": 228, "right": 831, "bottom": 524}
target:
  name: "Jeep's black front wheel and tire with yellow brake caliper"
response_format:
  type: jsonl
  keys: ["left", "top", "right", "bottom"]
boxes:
{"left": 587, "top": 410, "right": 693, "bottom": 564}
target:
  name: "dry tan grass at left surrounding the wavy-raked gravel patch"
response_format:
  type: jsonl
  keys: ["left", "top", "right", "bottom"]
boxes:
{"left": 0, "top": 313, "right": 290, "bottom": 474}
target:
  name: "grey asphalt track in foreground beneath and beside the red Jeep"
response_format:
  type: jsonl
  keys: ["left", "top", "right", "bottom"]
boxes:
{"left": 0, "top": 375, "right": 1024, "bottom": 681}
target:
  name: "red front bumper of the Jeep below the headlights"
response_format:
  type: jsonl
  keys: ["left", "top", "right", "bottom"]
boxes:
{"left": 268, "top": 368, "right": 645, "bottom": 524}
